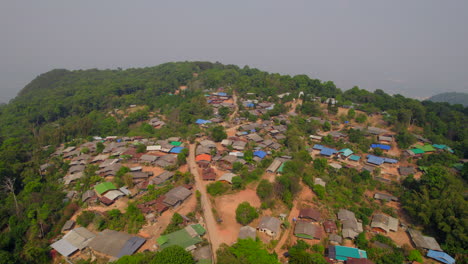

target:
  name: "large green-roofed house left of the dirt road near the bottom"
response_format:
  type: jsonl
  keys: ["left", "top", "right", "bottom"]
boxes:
{"left": 156, "top": 224, "right": 206, "bottom": 250}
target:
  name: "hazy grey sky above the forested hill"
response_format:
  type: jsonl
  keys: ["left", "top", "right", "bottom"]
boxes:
{"left": 0, "top": 0, "right": 468, "bottom": 102}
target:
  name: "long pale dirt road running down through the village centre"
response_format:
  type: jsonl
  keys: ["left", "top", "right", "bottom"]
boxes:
{"left": 188, "top": 144, "right": 221, "bottom": 263}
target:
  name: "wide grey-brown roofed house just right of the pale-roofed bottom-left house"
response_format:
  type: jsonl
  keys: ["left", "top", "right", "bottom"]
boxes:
{"left": 89, "top": 229, "right": 146, "bottom": 259}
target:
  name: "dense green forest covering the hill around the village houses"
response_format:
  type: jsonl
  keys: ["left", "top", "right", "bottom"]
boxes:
{"left": 0, "top": 62, "right": 468, "bottom": 263}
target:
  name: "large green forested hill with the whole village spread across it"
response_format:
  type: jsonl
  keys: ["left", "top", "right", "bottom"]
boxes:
{"left": 0, "top": 62, "right": 468, "bottom": 264}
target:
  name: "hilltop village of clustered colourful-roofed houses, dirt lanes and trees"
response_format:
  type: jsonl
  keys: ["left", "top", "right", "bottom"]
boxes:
{"left": 40, "top": 89, "right": 463, "bottom": 264}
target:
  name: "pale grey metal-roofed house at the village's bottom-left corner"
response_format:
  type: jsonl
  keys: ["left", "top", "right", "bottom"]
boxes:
{"left": 50, "top": 227, "right": 96, "bottom": 257}
